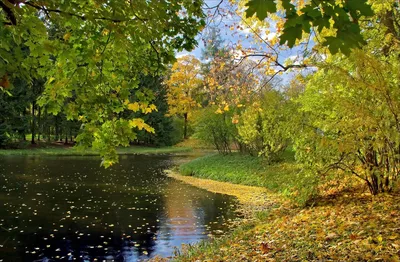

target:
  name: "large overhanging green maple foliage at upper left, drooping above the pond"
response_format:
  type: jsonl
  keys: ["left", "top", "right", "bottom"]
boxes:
{"left": 0, "top": 0, "right": 204, "bottom": 165}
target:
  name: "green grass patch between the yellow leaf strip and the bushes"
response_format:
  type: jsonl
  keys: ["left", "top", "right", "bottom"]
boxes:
{"left": 179, "top": 151, "right": 314, "bottom": 205}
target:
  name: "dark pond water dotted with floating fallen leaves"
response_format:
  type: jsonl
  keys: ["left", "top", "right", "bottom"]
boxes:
{"left": 0, "top": 156, "right": 236, "bottom": 262}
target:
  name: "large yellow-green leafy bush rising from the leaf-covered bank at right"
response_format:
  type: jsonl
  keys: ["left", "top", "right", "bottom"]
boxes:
{"left": 294, "top": 48, "right": 400, "bottom": 194}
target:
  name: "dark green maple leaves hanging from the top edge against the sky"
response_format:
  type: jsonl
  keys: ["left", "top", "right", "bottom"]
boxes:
{"left": 246, "top": 0, "right": 374, "bottom": 55}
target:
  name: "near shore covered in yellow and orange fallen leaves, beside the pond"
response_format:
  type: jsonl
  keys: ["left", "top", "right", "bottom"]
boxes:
{"left": 163, "top": 157, "right": 400, "bottom": 262}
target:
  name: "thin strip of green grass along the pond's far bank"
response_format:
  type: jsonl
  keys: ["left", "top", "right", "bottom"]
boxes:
{"left": 0, "top": 146, "right": 191, "bottom": 156}
